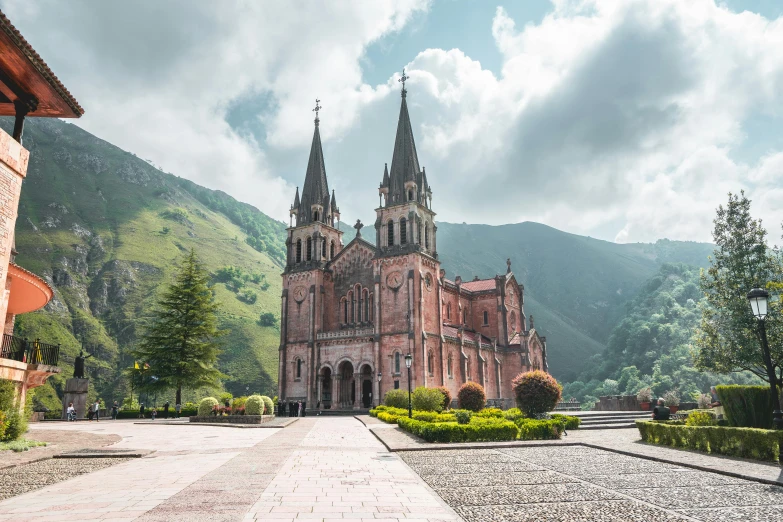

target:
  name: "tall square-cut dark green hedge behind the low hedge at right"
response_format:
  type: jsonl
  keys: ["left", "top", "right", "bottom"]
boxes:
{"left": 715, "top": 385, "right": 772, "bottom": 429}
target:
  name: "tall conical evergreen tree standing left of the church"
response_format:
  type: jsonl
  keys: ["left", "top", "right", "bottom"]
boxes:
{"left": 134, "top": 249, "right": 226, "bottom": 404}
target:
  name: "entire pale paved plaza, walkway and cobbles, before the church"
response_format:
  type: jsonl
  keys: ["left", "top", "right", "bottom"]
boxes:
{"left": 0, "top": 417, "right": 783, "bottom": 522}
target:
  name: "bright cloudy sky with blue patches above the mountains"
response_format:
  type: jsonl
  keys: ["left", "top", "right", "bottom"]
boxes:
{"left": 0, "top": 0, "right": 783, "bottom": 242}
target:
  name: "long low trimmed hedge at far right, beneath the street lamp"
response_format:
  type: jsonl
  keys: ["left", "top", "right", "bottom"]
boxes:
{"left": 636, "top": 420, "right": 783, "bottom": 461}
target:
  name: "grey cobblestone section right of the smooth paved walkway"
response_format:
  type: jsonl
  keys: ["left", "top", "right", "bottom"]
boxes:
{"left": 397, "top": 446, "right": 783, "bottom": 522}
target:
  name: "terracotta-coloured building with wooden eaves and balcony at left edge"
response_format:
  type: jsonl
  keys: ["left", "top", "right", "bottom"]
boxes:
{"left": 0, "top": 12, "right": 84, "bottom": 408}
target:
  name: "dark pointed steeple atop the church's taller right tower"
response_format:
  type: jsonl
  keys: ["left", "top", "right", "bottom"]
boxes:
{"left": 384, "top": 71, "right": 421, "bottom": 207}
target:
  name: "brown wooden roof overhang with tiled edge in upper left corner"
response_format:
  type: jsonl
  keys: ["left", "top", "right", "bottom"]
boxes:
{"left": 0, "top": 11, "right": 84, "bottom": 143}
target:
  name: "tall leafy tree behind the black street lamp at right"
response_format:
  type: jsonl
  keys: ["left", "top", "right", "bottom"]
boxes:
{"left": 695, "top": 193, "right": 783, "bottom": 386}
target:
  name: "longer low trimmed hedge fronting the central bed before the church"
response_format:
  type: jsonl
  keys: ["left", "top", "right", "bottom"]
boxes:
{"left": 397, "top": 417, "right": 519, "bottom": 442}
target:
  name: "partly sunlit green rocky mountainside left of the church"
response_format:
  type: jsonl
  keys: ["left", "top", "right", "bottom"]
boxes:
{"left": 2, "top": 119, "right": 285, "bottom": 410}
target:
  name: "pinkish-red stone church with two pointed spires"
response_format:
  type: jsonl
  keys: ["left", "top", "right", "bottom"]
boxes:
{"left": 278, "top": 83, "right": 547, "bottom": 409}
